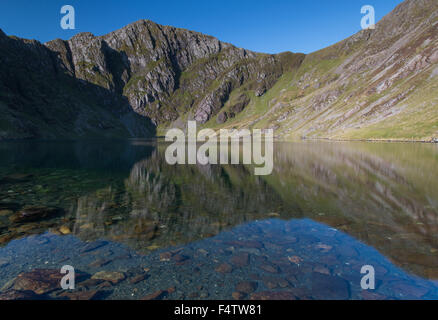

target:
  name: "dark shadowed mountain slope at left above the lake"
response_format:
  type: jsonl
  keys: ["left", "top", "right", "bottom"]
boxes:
{"left": 0, "top": 32, "right": 154, "bottom": 140}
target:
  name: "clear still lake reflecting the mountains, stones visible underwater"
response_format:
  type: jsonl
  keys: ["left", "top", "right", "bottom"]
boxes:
{"left": 0, "top": 140, "right": 438, "bottom": 299}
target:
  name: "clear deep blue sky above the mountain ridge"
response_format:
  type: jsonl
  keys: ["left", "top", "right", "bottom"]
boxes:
{"left": 0, "top": 0, "right": 402, "bottom": 53}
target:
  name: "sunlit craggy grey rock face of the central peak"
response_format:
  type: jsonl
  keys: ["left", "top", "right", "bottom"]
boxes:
{"left": 46, "top": 20, "right": 302, "bottom": 124}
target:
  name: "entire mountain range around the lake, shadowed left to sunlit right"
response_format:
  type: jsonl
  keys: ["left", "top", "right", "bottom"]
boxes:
{"left": 0, "top": 0, "right": 438, "bottom": 139}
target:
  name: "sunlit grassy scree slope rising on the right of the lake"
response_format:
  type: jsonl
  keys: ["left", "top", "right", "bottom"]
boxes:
{"left": 217, "top": 0, "right": 438, "bottom": 140}
